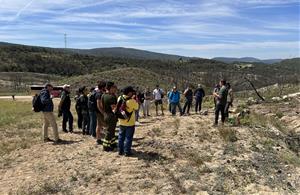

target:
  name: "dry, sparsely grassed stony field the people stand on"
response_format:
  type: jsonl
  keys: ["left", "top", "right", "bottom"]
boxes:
{"left": 0, "top": 88, "right": 300, "bottom": 194}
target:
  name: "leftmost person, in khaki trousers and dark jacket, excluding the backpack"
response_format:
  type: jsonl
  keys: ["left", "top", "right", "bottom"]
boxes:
{"left": 40, "top": 83, "right": 62, "bottom": 143}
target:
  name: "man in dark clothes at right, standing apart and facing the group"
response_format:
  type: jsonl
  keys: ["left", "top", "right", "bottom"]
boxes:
{"left": 213, "top": 80, "right": 228, "bottom": 126}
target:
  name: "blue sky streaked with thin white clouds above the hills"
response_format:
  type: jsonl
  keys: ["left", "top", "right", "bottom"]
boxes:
{"left": 0, "top": 0, "right": 300, "bottom": 59}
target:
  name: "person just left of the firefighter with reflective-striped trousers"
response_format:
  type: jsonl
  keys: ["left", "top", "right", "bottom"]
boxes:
{"left": 96, "top": 81, "right": 106, "bottom": 145}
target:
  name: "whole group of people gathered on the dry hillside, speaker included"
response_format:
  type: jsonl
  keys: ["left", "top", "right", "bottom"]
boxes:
{"left": 39, "top": 80, "right": 233, "bottom": 156}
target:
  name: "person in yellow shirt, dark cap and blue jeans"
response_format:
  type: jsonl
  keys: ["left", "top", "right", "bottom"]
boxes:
{"left": 117, "top": 86, "right": 139, "bottom": 156}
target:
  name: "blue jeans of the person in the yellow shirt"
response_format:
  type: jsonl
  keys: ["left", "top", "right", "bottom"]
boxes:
{"left": 119, "top": 125, "right": 135, "bottom": 154}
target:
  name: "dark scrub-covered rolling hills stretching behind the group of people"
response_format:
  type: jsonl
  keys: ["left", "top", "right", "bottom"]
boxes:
{"left": 0, "top": 43, "right": 300, "bottom": 90}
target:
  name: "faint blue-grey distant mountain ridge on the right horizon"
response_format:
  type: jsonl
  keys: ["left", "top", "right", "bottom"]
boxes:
{"left": 212, "top": 57, "right": 284, "bottom": 64}
